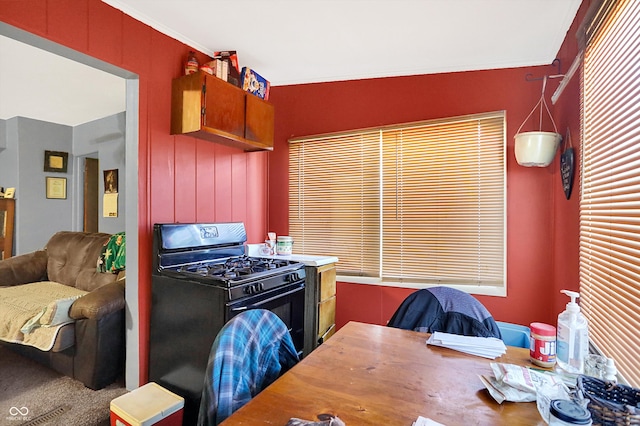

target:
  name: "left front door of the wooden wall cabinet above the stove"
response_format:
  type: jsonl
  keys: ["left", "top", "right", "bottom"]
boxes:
{"left": 202, "top": 75, "right": 245, "bottom": 138}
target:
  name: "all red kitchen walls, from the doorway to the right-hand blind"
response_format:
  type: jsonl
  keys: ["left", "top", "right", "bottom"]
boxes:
{"left": 0, "top": 0, "right": 589, "bottom": 383}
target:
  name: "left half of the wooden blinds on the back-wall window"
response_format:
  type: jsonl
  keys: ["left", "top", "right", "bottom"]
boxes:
{"left": 289, "top": 131, "right": 380, "bottom": 277}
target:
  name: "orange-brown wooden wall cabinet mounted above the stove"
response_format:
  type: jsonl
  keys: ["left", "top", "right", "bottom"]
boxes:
{"left": 171, "top": 71, "right": 274, "bottom": 151}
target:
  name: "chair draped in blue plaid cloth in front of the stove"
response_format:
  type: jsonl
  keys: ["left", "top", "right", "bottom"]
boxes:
{"left": 198, "top": 309, "right": 299, "bottom": 426}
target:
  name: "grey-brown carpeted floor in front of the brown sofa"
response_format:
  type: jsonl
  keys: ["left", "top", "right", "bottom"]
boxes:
{"left": 0, "top": 347, "right": 127, "bottom": 426}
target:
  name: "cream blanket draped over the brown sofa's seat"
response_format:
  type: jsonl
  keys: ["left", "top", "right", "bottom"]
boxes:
{"left": 0, "top": 281, "right": 87, "bottom": 351}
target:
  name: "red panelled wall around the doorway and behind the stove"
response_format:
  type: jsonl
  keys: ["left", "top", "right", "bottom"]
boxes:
{"left": 0, "top": 0, "right": 267, "bottom": 383}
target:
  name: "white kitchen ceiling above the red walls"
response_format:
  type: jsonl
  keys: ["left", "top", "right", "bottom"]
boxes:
{"left": 102, "top": 0, "right": 581, "bottom": 86}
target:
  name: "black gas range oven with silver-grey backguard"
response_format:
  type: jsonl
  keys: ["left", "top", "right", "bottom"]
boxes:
{"left": 149, "top": 223, "right": 306, "bottom": 425}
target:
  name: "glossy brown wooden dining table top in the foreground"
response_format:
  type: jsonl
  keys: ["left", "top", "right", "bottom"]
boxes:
{"left": 222, "top": 322, "right": 546, "bottom": 426}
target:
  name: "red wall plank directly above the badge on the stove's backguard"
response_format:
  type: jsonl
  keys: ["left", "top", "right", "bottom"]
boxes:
{"left": 196, "top": 140, "right": 216, "bottom": 222}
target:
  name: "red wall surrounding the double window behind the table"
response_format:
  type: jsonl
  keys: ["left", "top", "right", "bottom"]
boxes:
{"left": 269, "top": 0, "right": 584, "bottom": 327}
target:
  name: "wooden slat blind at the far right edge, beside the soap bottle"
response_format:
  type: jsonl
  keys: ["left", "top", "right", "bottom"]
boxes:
{"left": 580, "top": 0, "right": 640, "bottom": 386}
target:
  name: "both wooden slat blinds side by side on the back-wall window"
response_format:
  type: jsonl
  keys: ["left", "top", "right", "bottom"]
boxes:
{"left": 289, "top": 112, "right": 505, "bottom": 287}
